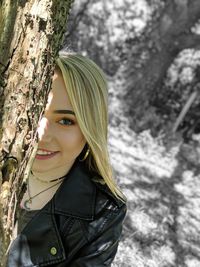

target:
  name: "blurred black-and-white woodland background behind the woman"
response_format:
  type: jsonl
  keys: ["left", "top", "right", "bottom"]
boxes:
{"left": 64, "top": 0, "right": 200, "bottom": 267}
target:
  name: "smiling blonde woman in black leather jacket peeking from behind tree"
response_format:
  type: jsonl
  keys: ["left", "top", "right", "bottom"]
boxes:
{"left": 7, "top": 53, "right": 126, "bottom": 267}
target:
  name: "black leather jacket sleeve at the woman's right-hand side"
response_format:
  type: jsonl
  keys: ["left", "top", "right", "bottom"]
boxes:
{"left": 67, "top": 205, "right": 126, "bottom": 267}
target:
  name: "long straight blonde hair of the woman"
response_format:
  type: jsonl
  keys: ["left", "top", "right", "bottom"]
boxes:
{"left": 56, "top": 52, "right": 126, "bottom": 202}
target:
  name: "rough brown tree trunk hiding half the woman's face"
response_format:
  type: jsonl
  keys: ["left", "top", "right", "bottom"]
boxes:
{"left": 0, "top": 0, "right": 73, "bottom": 266}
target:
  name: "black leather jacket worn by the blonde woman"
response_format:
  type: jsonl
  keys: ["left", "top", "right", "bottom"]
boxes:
{"left": 7, "top": 161, "right": 126, "bottom": 267}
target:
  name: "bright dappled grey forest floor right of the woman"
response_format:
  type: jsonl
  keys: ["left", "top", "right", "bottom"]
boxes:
{"left": 109, "top": 81, "right": 200, "bottom": 267}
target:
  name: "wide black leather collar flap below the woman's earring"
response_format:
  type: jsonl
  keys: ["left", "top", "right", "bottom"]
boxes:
{"left": 49, "top": 160, "right": 96, "bottom": 220}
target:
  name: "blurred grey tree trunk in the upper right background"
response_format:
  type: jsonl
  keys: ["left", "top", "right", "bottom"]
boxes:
{"left": 124, "top": 0, "right": 200, "bottom": 130}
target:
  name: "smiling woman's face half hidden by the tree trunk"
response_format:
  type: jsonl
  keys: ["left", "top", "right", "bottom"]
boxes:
{"left": 32, "top": 72, "right": 86, "bottom": 177}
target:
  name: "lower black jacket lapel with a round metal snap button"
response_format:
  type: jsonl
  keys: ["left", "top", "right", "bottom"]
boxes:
{"left": 22, "top": 209, "right": 66, "bottom": 266}
